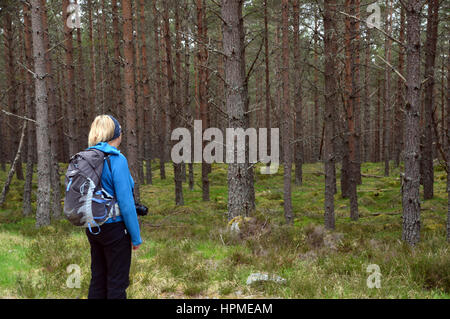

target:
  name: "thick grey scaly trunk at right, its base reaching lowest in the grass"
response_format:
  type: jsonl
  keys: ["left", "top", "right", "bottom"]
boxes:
{"left": 402, "top": 0, "right": 422, "bottom": 246}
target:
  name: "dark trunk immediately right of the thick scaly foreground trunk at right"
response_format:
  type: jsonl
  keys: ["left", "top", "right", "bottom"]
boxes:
{"left": 422, "top": 0, "right": 439, "bottom": 199}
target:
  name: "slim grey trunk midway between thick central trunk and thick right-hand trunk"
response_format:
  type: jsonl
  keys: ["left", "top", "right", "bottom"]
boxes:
{"left": 323, "top": 0, "right": 337, "bottom": 229}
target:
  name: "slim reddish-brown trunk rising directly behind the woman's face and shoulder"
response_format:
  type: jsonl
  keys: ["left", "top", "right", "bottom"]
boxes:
{"left": 122, "top": 0, "right": 140, "bottom": 201}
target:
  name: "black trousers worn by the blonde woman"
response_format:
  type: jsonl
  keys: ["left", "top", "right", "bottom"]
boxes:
{"left": 86, "top": 222, "right": 131, "bottom": 299}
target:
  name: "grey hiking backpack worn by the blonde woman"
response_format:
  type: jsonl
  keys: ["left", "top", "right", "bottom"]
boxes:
{"left": 64, "top": 148, "right": 118, "bottom": 234}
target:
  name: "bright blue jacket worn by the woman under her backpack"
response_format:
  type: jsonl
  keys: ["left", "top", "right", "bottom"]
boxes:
{"left": 90, "top": 142, "right": 142, "bottom": 246}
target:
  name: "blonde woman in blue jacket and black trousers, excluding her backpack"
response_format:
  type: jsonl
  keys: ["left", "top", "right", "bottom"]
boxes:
{"left": 86, "top": 115, "right": 142, "bottom": 299}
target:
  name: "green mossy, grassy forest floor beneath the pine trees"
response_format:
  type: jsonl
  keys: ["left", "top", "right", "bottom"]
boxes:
{"left": 0, "top": 163, "right": 450, "bottom": 298}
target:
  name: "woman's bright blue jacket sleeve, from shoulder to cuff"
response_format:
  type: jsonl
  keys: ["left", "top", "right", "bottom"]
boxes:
{"left": 111, "top": 154, "right": 142, "bottom": 246}
